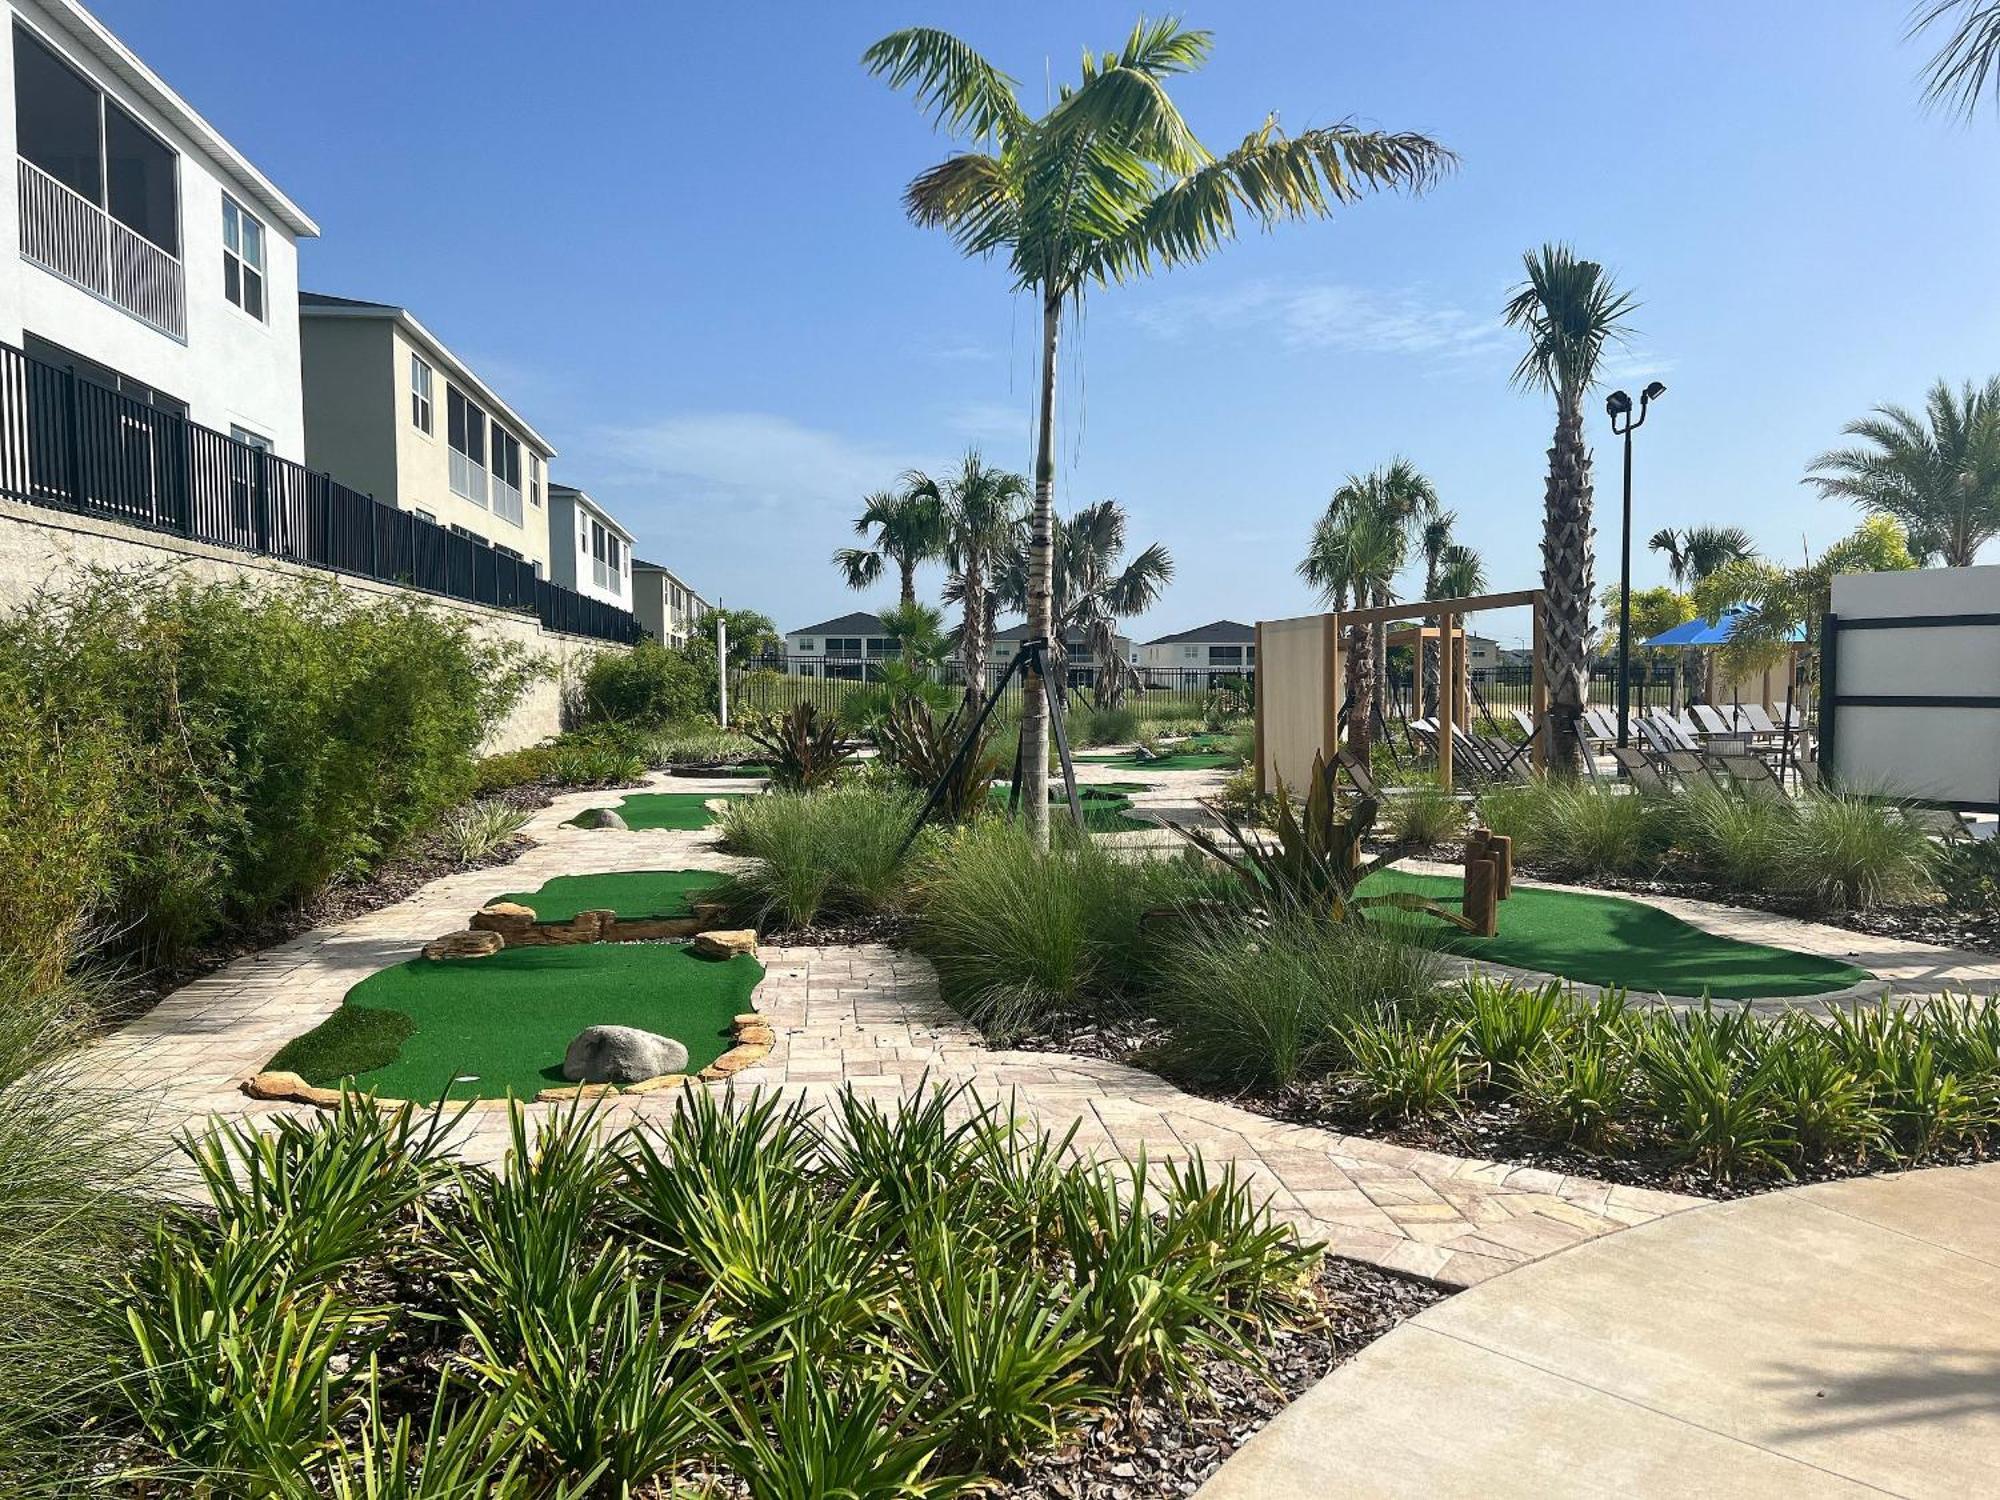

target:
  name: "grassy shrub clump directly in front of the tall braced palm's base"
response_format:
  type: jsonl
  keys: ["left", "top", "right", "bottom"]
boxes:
{"left": 916, "top": 818, "right": 1210, "bottom": 1044}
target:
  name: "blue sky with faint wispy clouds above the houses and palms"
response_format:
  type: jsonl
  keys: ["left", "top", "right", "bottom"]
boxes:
{"left": 96, "top": 0, "right": 2000, "bottom": 638}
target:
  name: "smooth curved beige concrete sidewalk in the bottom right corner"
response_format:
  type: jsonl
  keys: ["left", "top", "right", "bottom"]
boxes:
{"left": 1200, "top": 1164, "right": 2000, "bottom": 1500}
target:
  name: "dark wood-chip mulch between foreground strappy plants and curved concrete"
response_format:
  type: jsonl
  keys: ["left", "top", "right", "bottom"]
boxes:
{"left": 994, "top": 1256, "right": 1448, "bottom": 1500}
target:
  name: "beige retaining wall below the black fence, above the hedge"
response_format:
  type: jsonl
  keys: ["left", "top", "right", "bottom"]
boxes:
{"left": 0, "top": 500, "right": 616, "bottom": 752}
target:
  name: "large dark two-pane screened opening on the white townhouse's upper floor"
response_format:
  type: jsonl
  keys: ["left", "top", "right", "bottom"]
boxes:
{"left": 14, "top": 24, "right": 180, "bottom": 256}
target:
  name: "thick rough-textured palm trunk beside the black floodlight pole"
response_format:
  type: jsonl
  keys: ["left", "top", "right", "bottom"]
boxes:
{"left": 1542, "top": 398, "right": 1596, "bottom": 774}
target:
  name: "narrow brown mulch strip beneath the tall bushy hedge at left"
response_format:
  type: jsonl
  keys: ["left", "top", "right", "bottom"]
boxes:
{"left": 102, "top": 784, "right": 576, "bottom": 1026}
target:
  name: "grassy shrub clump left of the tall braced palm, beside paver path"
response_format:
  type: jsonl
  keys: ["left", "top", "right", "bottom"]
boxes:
{"left": 716, "top": 786, "right": 918, "bottom": 926}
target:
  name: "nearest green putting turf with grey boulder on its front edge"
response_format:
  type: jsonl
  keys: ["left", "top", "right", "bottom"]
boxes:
{"left": 270, "top": 942, "right": 764, "bottom": 1104}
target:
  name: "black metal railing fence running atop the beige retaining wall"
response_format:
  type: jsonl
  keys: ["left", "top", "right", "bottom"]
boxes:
{"left": 0, "top": 344, "right": 640, "bottom": 642}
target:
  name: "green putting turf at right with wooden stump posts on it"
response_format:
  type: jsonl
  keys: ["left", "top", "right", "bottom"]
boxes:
{"left": 1362, "top": 870, "right": 1874, "bottom": 1000}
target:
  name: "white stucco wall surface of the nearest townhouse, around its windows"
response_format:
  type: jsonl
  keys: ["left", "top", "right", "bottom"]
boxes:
{"left": 0, "top": 0, "right": 306, "bottom": 460}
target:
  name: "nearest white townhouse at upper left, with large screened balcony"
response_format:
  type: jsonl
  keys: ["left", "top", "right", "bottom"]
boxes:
{"left": 0, "top": 0, "right": 320, "bottom": 462}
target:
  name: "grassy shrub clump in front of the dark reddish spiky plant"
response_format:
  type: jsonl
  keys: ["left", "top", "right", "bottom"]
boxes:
{"left": 1154, "top": 916, "right": 1442, "bottom": 1090}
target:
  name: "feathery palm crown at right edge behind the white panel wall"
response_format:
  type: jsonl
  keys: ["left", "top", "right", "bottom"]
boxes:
{"left": 1806, "top": 376, "right": 2000, "bottom": 568}
